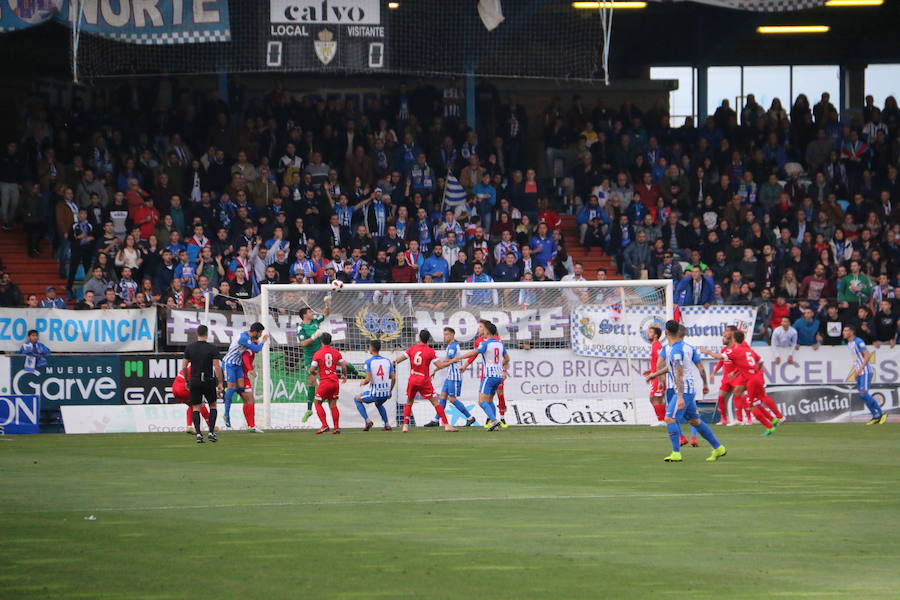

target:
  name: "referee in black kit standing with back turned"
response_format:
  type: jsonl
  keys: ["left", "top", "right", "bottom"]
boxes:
{"left": 181, "top": 325, "right": 224, "bottom": 444}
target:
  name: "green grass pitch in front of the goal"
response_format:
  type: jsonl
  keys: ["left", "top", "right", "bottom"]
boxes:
{"left": 0, "top": 423, "right": 900, "bottom": 600}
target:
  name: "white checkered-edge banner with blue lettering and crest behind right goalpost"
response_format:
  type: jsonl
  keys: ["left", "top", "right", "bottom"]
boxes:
{"left": 571, "top": 302, "right": 756, "bottom": 359}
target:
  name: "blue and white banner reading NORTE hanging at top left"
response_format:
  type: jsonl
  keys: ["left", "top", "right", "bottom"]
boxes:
{"left": 0, "top": 0, "right": 231, "bottom": 46}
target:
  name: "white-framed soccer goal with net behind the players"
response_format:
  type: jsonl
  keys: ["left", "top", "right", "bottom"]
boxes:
{"left": 243, "top": 280, "right": 673, "bottom": 429}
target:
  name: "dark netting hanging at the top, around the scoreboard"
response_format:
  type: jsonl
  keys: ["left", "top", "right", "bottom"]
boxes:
{"left": 75, "top": 0, "right": 616, "bottom": 79}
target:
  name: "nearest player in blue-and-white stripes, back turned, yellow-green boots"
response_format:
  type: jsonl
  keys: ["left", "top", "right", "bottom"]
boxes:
{"left": 647, "top": 321, "right": 728, "bottom": 462}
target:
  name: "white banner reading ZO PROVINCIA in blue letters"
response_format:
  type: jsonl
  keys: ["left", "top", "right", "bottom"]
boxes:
{"left": 0, "top": 308, "right": 156, "bottom": 352}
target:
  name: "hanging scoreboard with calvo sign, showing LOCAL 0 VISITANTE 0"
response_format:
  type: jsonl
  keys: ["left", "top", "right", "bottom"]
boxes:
{"left": 264, "top": 0, "right": 390, "bottom": 72}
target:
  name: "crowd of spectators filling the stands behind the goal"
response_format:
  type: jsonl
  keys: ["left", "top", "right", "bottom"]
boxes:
{"left": 0, "top": 79, "right": 900, "bottom": 345}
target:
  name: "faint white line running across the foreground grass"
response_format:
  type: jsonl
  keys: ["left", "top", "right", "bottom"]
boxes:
{"left": 0, "top": 490, "right": 880, "bottom": 515}
